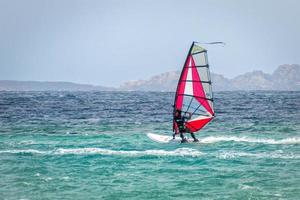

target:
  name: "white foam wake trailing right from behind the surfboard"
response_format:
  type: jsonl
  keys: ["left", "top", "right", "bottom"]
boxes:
{"left": 200, "top": 136, "right": 300, "bottom": 144}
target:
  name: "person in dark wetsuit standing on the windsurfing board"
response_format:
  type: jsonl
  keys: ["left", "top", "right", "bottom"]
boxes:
{"left": 173, "top": 110, "right": 199, "bottom": 143}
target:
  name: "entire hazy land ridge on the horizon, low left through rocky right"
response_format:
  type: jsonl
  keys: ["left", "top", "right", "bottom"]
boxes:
{"left": 0, "top": 64, "right": 300, "bottom": 91}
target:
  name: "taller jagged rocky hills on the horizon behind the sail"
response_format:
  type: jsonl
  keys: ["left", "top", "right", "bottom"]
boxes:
{"left": 120, "top": 64, "right": 300, "bottom": 91}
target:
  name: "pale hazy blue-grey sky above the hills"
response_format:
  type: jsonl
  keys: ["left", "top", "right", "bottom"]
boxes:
{"left": 0, "top": 0, "right": 300, "bottom": 86}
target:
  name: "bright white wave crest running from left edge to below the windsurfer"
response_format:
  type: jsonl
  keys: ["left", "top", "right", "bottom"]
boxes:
{"left": 0, "top": 148, "right": 204, "bottom": 157}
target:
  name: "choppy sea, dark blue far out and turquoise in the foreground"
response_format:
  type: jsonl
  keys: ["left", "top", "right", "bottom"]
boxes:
{"left": 0, "top": 91, "right": 300, "bottom": 200}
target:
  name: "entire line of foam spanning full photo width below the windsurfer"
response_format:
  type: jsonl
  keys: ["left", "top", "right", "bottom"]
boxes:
{"left": 0, "top": 148, "right": 300, "bottom": 159}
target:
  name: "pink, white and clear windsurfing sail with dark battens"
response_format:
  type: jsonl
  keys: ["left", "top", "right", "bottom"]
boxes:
{"left": 173, "top": 43, "right": 215, "bottom": 132}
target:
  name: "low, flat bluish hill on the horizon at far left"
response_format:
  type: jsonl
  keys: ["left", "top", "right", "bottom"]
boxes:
{"left": 0, "top": 80, "right": 114, "bottom": 91}
